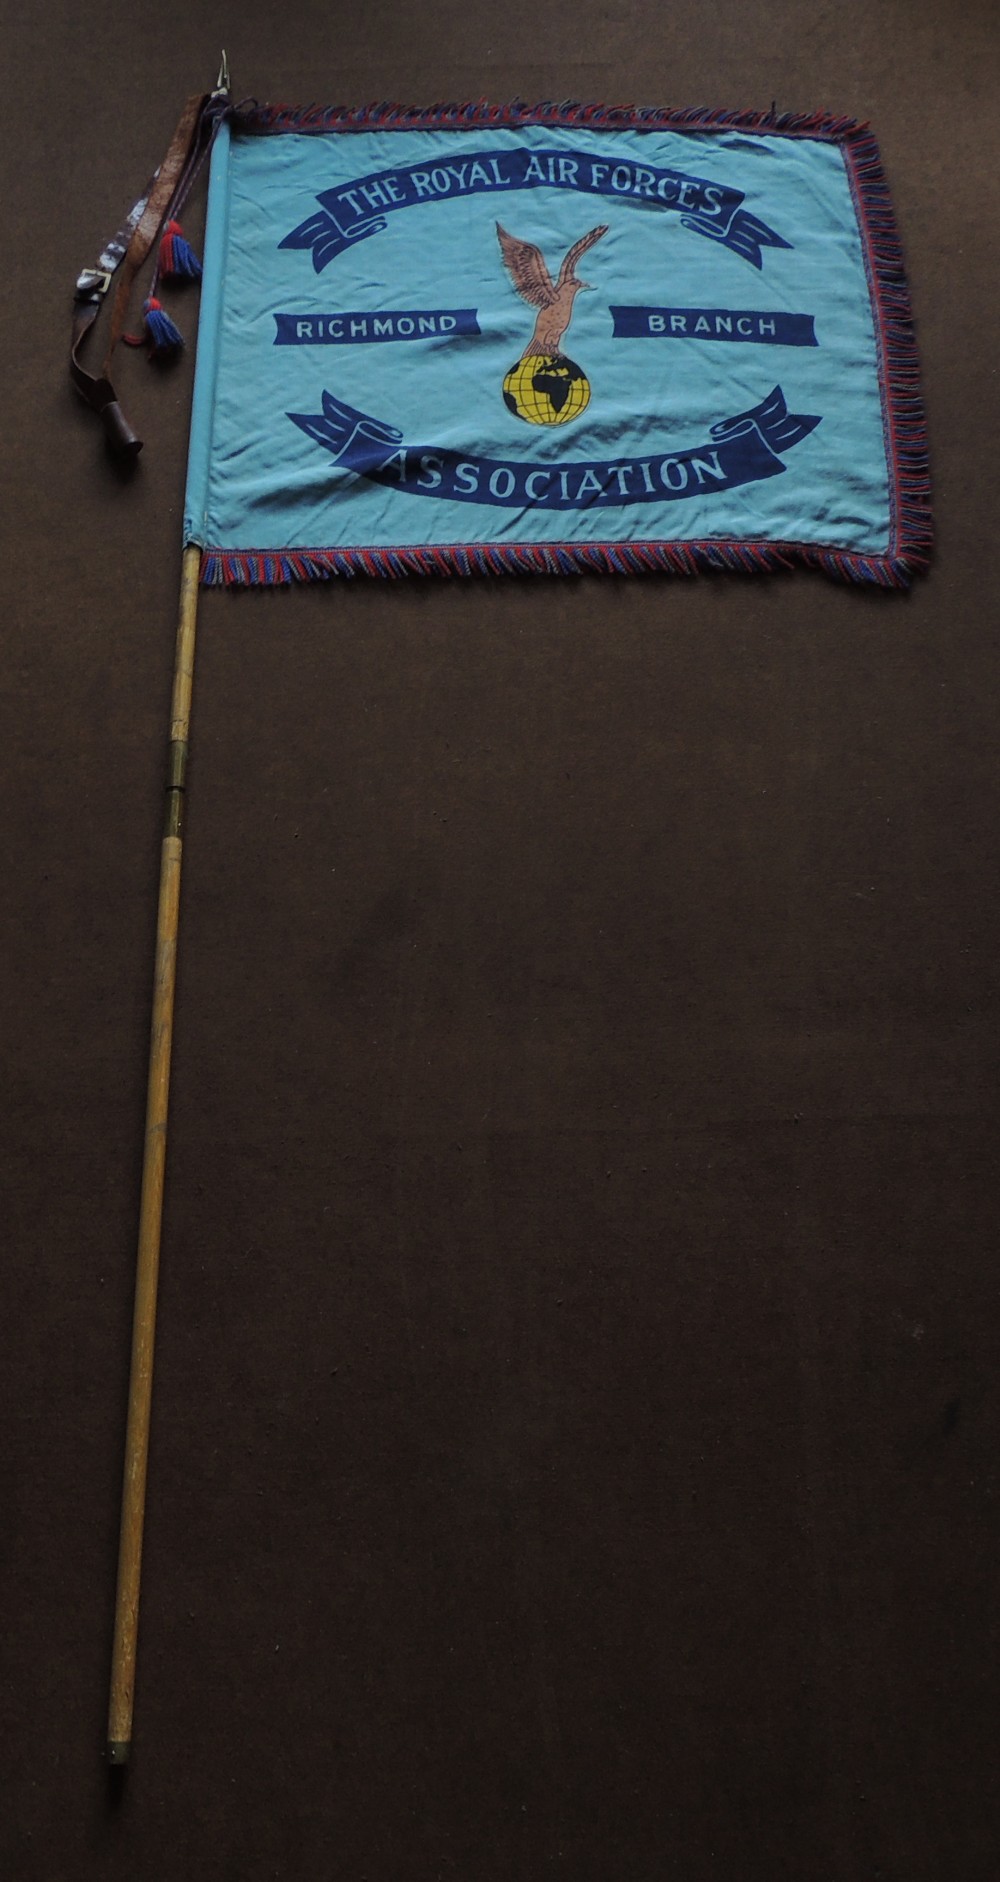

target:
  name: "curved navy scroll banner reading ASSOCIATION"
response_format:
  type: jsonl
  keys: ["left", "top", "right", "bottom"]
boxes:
{"left": 288, "top": 386, "right": 821, "bottom": 510}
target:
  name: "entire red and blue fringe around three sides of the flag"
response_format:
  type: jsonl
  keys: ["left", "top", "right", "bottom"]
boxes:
{"left": 202, "top": 100, "right": 932, "bottom": 589}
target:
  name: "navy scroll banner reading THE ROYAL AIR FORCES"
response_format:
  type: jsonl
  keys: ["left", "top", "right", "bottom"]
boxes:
{"left": 279, "top": 149, "right": 791, "bottom": 275}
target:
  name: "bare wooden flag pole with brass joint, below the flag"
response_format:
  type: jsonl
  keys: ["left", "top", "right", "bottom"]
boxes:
{"left": 107, "top": 548, "right": 202, "bottom": 1765}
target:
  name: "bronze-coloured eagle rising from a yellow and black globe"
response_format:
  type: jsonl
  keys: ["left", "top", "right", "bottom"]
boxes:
{"left": 497, "top": 222, "right": 608, "bottom": 425}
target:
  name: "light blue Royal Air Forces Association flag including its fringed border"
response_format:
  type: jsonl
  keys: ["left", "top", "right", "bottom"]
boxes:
{"left": 185, "top": 107, "right": 928, "bottom": 585}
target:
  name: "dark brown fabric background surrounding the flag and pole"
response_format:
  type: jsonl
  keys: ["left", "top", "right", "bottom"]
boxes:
{"left": 0, "top": 0, "right": 1000, "bottom": 1882}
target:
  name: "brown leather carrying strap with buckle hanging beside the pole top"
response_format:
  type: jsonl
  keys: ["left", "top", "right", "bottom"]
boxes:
{"left": 70, "top": 92, "right": 218, "bottom": 459}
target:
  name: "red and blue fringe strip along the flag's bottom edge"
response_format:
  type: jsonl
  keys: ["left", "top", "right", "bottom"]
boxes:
{"left": 202, "top": 542, "right": 913, "bottom": 589}
